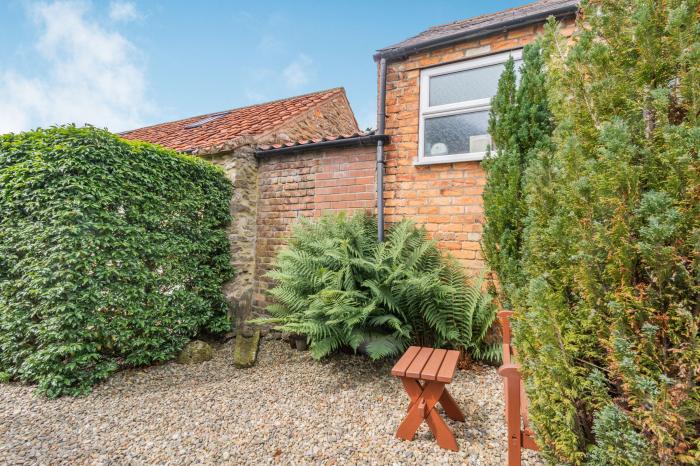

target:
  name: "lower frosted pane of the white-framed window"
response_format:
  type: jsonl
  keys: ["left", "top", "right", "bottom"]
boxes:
{"left": 423, "top": 110, "right": 491, "bottom": 157}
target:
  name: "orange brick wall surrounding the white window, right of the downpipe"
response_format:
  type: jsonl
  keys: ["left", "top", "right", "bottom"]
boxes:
{"left": 384, "top": 19, "right": 574, "bottom": 273}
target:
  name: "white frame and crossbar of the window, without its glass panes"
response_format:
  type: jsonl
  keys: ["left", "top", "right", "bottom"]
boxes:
{"left": 414, "top": 49, "right": 523, "bottom": 165}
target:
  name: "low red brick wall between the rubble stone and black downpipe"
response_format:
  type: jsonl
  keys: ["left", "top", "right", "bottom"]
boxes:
{"left": 254, "top": 145, "right": 376, "bottom": 308}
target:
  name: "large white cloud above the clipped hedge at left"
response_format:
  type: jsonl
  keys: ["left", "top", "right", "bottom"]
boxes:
{"left": 0, "top": 1, "right": 153, "bottom": 133}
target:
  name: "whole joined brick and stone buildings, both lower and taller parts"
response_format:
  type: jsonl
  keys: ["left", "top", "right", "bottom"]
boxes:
{"left": 123, "top": 0, "right": 577, "bottom": 314}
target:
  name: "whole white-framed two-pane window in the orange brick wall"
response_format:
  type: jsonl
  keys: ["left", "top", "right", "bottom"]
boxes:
{"left": 415, "top": 50, "right": 522, "bottom": 165}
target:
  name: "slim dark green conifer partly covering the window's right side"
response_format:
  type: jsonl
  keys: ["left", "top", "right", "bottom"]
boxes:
{"left": 482, "top": 43, "right": 554, "bottom": 308}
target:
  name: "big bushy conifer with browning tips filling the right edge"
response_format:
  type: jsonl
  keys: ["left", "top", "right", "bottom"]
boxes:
{"left": 500, "top": 0, "right": 700, "bottom": 465}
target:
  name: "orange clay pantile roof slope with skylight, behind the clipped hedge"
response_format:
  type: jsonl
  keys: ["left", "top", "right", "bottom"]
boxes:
{"left": 120, "top": 87, "right": 345, "bottom": 152}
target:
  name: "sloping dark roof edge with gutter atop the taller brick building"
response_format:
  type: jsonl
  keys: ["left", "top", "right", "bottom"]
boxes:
{"left": 373, "top": 4, "right": 578, "bottom": 61}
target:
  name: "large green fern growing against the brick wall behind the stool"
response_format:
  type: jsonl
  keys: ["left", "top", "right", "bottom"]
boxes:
{"left": 252, "top": 214, "right": 500, "bottom": 362}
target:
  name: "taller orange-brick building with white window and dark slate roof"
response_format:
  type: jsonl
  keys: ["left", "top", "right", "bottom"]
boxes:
{"left": 375, "top": 0, "right": 577, "bottom": 273}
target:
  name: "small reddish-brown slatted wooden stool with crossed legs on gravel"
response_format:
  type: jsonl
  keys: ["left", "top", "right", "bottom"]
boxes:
{"left": 391, "top": 346, "right": 464, "bottom": 451}
